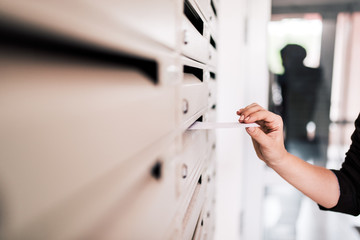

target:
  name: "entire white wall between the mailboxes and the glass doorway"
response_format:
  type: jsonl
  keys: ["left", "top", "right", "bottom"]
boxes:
{"left": 215, "top": 0, "right": 270, "bottom": 240}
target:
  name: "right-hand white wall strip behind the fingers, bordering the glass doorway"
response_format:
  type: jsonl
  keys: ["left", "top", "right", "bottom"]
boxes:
{"left": 241, "top": 0, "right": 271, "bottom": 240}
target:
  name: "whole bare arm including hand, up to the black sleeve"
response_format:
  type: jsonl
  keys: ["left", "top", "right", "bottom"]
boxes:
{"left": 237, "top": 104, "right": 340, "bottom": 208}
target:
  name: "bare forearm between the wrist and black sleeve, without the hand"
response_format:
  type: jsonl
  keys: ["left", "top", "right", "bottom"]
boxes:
{"left": 268, "top": 153, "right": 340, "bottom": 208}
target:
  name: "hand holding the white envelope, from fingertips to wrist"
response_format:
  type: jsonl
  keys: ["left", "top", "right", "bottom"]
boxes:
{"left": 236, "top": 103, "right": 288, "bottom": 167}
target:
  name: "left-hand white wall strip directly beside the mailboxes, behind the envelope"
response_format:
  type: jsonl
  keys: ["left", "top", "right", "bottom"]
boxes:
{"left": 215, "top": 0, "right": 245, "bottom": 240}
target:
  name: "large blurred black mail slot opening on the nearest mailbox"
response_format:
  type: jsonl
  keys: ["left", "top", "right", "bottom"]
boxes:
{"left": 0, "top": 21, "right": 159, "bottom": 84}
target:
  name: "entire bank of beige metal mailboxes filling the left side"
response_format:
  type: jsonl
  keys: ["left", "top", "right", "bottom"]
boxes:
{"left": 0, "top": 0, "right": 217, "bottom": 240}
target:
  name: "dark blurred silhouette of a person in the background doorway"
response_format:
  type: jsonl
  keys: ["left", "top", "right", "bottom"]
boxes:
{"left": 278, "top": 44, "right": 322, "bottom": 158}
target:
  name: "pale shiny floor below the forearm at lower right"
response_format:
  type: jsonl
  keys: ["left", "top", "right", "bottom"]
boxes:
{"left": 264, "top": 174, "right": 360, "bottom": 240}
